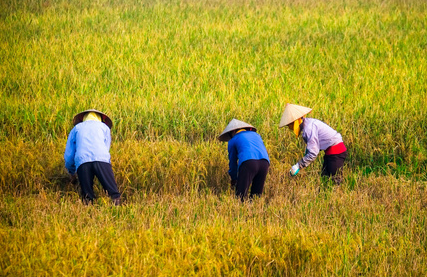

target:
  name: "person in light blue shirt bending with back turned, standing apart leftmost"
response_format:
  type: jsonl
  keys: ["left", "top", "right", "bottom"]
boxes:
{"left": 64, "top": 109, "right": 121, "bottom": 206}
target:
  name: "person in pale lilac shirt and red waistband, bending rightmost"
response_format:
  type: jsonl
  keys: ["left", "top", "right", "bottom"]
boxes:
{"left": 279, "top": 104, "right": 347, "bottom": 185}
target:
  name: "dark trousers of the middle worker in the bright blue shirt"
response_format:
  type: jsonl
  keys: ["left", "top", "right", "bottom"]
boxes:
{"left": 236, "top": 160, "right": 270, "bottom": 201}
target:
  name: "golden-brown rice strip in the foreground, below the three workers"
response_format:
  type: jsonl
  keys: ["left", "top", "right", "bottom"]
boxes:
{"left": 0, "top": 177, "right": 426, "bottom": 276}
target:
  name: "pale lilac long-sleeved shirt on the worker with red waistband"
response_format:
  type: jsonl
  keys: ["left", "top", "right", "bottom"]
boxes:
{"left": 298, "top": 118, "right": 342, "bottom": 168}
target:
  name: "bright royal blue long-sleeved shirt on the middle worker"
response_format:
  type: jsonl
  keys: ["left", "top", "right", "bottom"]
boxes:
{"left": 228, "top": 131, "right": 270, "bottom": 180}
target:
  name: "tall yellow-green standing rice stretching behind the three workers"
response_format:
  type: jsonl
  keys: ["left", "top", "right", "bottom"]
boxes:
{"left": 0, "top": 1, "right": 427, "bottom": 174}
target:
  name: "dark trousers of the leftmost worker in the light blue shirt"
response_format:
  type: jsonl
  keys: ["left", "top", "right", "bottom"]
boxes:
{"left": 77, "top": 162, "right": 120, "bottom": 202}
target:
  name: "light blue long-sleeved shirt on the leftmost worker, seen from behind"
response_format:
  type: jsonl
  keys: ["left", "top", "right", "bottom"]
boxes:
{"left": 64, "top": 120, "right": 111, "bottom": 174}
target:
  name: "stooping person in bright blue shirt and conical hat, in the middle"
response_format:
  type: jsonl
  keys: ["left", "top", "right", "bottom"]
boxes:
{"left": 218, "top": 119, "right": 270, "bottom": 201}
